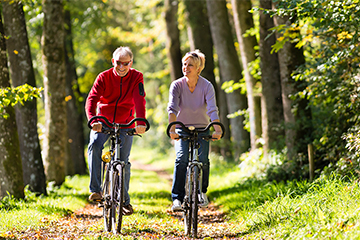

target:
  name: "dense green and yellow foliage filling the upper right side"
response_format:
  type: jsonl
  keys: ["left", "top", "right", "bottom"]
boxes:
{"left": 260, "top": 0, "right": 360, "bottom": 172}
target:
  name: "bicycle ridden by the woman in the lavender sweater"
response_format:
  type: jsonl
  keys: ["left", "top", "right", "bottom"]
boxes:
{"left": 166, "top": 121, "right": 225, "bottom": 238}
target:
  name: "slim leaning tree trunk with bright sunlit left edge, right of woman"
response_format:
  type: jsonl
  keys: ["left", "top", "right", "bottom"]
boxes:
{"left": 231, "top": 0, "right": 262, "bottom": 150}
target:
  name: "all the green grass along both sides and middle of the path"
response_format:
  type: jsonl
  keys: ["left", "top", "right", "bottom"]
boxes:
{"left": 0, "top": 149, "right": 360, "bottom": 239}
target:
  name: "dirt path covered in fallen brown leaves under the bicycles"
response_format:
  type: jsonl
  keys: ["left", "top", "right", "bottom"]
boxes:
{"left": 8, "top": 162, "right": 240, "bottom": 239}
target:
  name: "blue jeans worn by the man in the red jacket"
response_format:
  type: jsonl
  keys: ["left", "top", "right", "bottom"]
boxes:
{"left": 88, "top": 129, "right": 133, "bottom": 205}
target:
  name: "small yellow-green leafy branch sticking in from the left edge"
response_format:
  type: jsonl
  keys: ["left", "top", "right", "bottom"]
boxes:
{"left": 0, "top": 84, "right": 43, "bottom": 118}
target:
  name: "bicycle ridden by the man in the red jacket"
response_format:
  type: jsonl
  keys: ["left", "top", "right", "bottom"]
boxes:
{"left": 88, "top": 116, "right": 150, "bottom": 234}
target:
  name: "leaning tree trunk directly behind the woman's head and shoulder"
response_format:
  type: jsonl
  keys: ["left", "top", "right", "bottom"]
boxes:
{"left": 184, "top": 0, "right": 231, "bottom": 157}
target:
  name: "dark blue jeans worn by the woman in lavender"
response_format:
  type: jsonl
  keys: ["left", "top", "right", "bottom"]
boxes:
{"left": 171, "top": 129, "right": 210, "bottom": 202}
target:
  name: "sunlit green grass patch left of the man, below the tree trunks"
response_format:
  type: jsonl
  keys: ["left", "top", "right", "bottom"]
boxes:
{"left": 0, "top": 176, "right": 88, "bottom": 236}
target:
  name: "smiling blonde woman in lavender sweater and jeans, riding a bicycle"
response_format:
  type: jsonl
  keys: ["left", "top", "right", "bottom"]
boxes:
{"left": 167, "top": 50, "right": 222, "bottom": 211}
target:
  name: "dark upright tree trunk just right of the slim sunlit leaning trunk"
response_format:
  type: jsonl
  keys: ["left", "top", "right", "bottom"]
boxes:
{"left": 259, "top": 0, "right": 284, "bottom": 155}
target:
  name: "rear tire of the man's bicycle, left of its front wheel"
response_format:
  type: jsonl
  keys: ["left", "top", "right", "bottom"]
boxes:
{"left": 102, "top": 164, "right": 111, "bottom": 232}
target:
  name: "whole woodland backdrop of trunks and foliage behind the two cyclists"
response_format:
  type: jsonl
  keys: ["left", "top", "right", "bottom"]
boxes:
{"left": 0, "top": 0, "right": 360, "bottom": 198}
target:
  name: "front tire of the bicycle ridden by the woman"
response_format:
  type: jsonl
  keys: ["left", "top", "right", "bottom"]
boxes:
{"left": 190, "top": 165, "right": 199, "bottom": 238}
